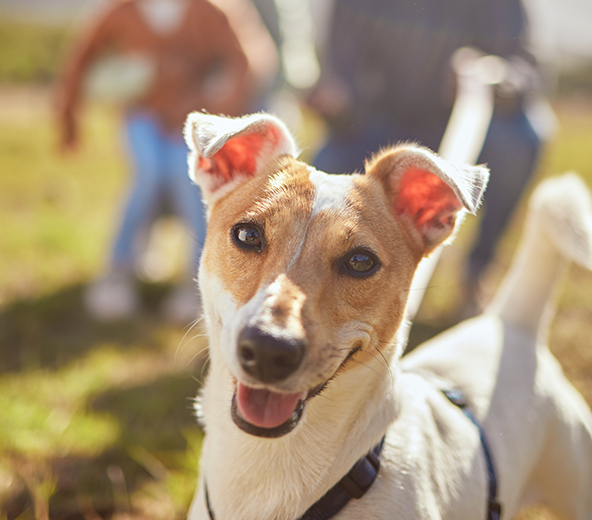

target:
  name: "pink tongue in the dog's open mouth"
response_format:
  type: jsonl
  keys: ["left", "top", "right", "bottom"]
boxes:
{"left": 236, "top": 383, "right": 303, "bottom": 428}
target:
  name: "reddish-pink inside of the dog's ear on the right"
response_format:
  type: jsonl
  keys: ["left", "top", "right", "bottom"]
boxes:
{"left": 395, "top": 168, "right": 462, "bottom": 227}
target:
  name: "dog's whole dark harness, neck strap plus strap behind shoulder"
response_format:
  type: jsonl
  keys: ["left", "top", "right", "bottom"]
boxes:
{"left": 204, "top": 390, "right": 502, "bottom": 520}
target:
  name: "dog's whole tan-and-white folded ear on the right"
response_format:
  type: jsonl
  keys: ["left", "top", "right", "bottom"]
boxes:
{"left": 366, "top": 145, "right": 489, "bottom": 255}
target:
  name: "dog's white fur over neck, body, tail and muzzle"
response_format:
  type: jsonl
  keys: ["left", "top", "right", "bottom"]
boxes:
{"left": 189, "top": 111, "right": 592, "bottom": 520}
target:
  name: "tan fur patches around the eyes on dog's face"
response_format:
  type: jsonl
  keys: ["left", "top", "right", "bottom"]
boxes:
{"left": 202, "top": 154, "right": 420, "bottom": 390}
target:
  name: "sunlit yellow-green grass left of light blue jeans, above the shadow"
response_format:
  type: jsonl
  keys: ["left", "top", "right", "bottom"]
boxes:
{"left": 0, "top": 89, "right": 125, "bottom": 302}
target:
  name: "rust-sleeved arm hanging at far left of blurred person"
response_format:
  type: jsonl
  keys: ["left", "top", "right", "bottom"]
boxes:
{"left": 56, "top": 6, "right": 117, "bottom": 150}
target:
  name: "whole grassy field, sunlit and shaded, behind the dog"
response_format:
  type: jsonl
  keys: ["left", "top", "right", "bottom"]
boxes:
{"left": 0, "top": 87, "right": 592, "bottom": 520}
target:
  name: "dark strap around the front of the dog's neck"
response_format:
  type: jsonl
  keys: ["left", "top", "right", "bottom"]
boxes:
{"left": 204, "top": 437, "right": 384, "bottom": 520}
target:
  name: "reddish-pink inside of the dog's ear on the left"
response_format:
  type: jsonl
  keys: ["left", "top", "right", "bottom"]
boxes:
{"left": 198, "top": 125, "right": 280, "bottom": 182}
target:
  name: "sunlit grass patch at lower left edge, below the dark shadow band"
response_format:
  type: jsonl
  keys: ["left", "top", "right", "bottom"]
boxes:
{"left": 0, "top": 349, "right": 124, "bottom": 457}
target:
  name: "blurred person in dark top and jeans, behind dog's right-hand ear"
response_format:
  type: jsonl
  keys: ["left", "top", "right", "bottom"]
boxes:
{"left": 309, "top": 0, "right": 550, "bottom": 314}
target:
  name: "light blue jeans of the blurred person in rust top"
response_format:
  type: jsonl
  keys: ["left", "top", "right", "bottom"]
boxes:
{"left": 111, "top": 112, "right": 206, "bottom": 273}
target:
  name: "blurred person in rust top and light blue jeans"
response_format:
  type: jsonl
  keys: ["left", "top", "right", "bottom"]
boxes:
{"left": 57, "top": 0, "right": 273, "bottom": 323}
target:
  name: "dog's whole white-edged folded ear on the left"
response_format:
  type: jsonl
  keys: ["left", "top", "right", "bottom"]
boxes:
{"left": 185, "top": 112, "right": 297, "bottom": 205}
